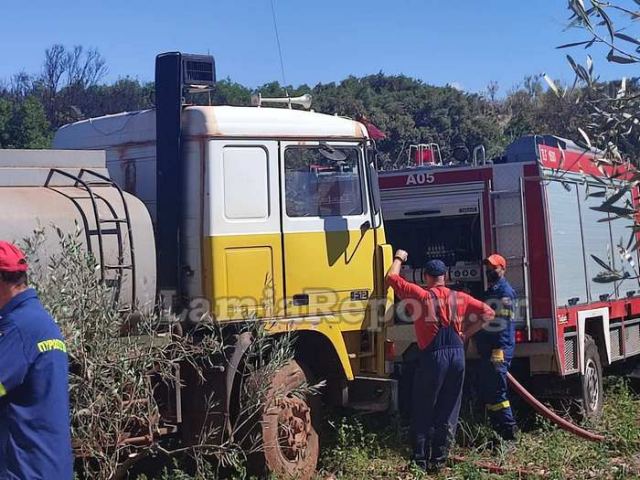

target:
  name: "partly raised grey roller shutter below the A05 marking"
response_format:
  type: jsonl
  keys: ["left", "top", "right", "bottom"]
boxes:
{"left": 384, "top": 193, "right": 480, "bottom": 220}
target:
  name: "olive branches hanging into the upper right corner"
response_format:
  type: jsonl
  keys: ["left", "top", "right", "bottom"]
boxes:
{"left": 545, "top": 0, "right": 640, "bottom": 282}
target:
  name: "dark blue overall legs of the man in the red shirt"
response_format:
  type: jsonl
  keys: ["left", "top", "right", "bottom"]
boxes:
{"left": 411, "top": 334, "right": 465, "bottom": 468}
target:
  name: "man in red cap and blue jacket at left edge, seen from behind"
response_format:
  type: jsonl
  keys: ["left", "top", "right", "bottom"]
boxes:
{"left": 0, "top": 241, "right": 73, "bottom": 480}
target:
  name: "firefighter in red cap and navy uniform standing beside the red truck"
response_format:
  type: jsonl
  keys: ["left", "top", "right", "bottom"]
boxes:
{"left": 476, "top": 253, "right": 516, "bottom": 440}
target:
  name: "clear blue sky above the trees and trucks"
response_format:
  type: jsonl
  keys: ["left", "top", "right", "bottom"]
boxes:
{"left": 0, "top": 0, "right": 630, "bottom": 94}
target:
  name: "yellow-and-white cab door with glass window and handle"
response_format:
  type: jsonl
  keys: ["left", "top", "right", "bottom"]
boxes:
{"left": 280, "top": 142, "right": 375, "bottom": 318}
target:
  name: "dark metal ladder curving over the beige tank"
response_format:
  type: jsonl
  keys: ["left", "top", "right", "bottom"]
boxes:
{"left": 45, "top": 168, "right": 136, "bottom": 306}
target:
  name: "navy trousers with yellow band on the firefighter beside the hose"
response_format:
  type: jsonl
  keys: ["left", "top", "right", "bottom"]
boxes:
{"left": 480, "top": 355, "right": 516, "bottom": 440}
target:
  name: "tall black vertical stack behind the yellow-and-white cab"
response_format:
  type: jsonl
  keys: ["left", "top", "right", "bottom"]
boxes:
{"left": 155, "top": 52, "right": 216, "bottom": 306}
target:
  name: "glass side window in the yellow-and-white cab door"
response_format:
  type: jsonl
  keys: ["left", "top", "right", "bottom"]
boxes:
{"left": 284, "top": 145, "right": 363, "bottom": 217}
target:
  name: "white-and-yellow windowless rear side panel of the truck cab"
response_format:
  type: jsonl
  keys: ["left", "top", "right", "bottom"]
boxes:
{"left": 204, "top": 140, "right": 284, "bottom": 320}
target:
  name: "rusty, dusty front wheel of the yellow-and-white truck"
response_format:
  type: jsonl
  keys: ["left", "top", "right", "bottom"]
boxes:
{"left": 261, "top": 360, "right": 320, "bottom": 480}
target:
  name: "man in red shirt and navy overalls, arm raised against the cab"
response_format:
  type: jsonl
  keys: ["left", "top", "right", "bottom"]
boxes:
{"left": 386, "top": 250, "right": 494, "bottom": 471}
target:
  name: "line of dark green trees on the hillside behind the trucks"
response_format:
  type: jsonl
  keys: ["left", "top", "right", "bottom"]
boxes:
{"left": 5, "top": 39, "right": 637, "bottom": 168}
